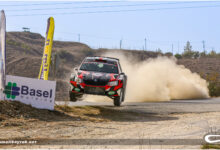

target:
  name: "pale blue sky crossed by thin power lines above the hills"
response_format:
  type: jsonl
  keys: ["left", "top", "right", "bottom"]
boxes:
{"left": 0, "top": 0, "right": 220, "bottom": 53}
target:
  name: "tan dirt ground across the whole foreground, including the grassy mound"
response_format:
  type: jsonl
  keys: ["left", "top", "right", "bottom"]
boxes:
{"left": 0, "top": 98, "right": 220, "bottom": 149}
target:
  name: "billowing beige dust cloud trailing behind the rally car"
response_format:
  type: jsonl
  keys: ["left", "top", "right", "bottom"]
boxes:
{"left": 85, "top": 53, "right": 209, "bottom": 102}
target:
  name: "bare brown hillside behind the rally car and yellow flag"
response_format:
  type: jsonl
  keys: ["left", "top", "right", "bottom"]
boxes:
{"left": 6, "top": 32, "right": 220, "bottom": 100}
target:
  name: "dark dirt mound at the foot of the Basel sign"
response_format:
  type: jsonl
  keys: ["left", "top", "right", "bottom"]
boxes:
{"left": 0, "top": 101, "right": 77, "bottom": 126}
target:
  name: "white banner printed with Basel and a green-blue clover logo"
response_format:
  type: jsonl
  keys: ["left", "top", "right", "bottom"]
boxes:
{"left": 4, "top": 75, "right": 56, "bottom": 110}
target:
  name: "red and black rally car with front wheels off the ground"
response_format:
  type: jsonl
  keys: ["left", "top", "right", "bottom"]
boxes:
{"left": 69, "top": 56, "right": 127, "bottom": 106}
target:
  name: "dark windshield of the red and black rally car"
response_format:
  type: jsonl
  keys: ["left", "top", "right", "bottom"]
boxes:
{"left": 80, "top": 62, "right": 118, "bottom": 74}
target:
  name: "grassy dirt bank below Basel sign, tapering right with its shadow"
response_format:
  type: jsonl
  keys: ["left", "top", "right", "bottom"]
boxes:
{"left": 0, "top": 101, "right": 163, "bottom": 127}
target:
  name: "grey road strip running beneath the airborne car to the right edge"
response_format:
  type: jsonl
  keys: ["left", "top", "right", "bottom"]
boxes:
{"left": 56, "top": 97, "right": 220, "bottom": 114}
